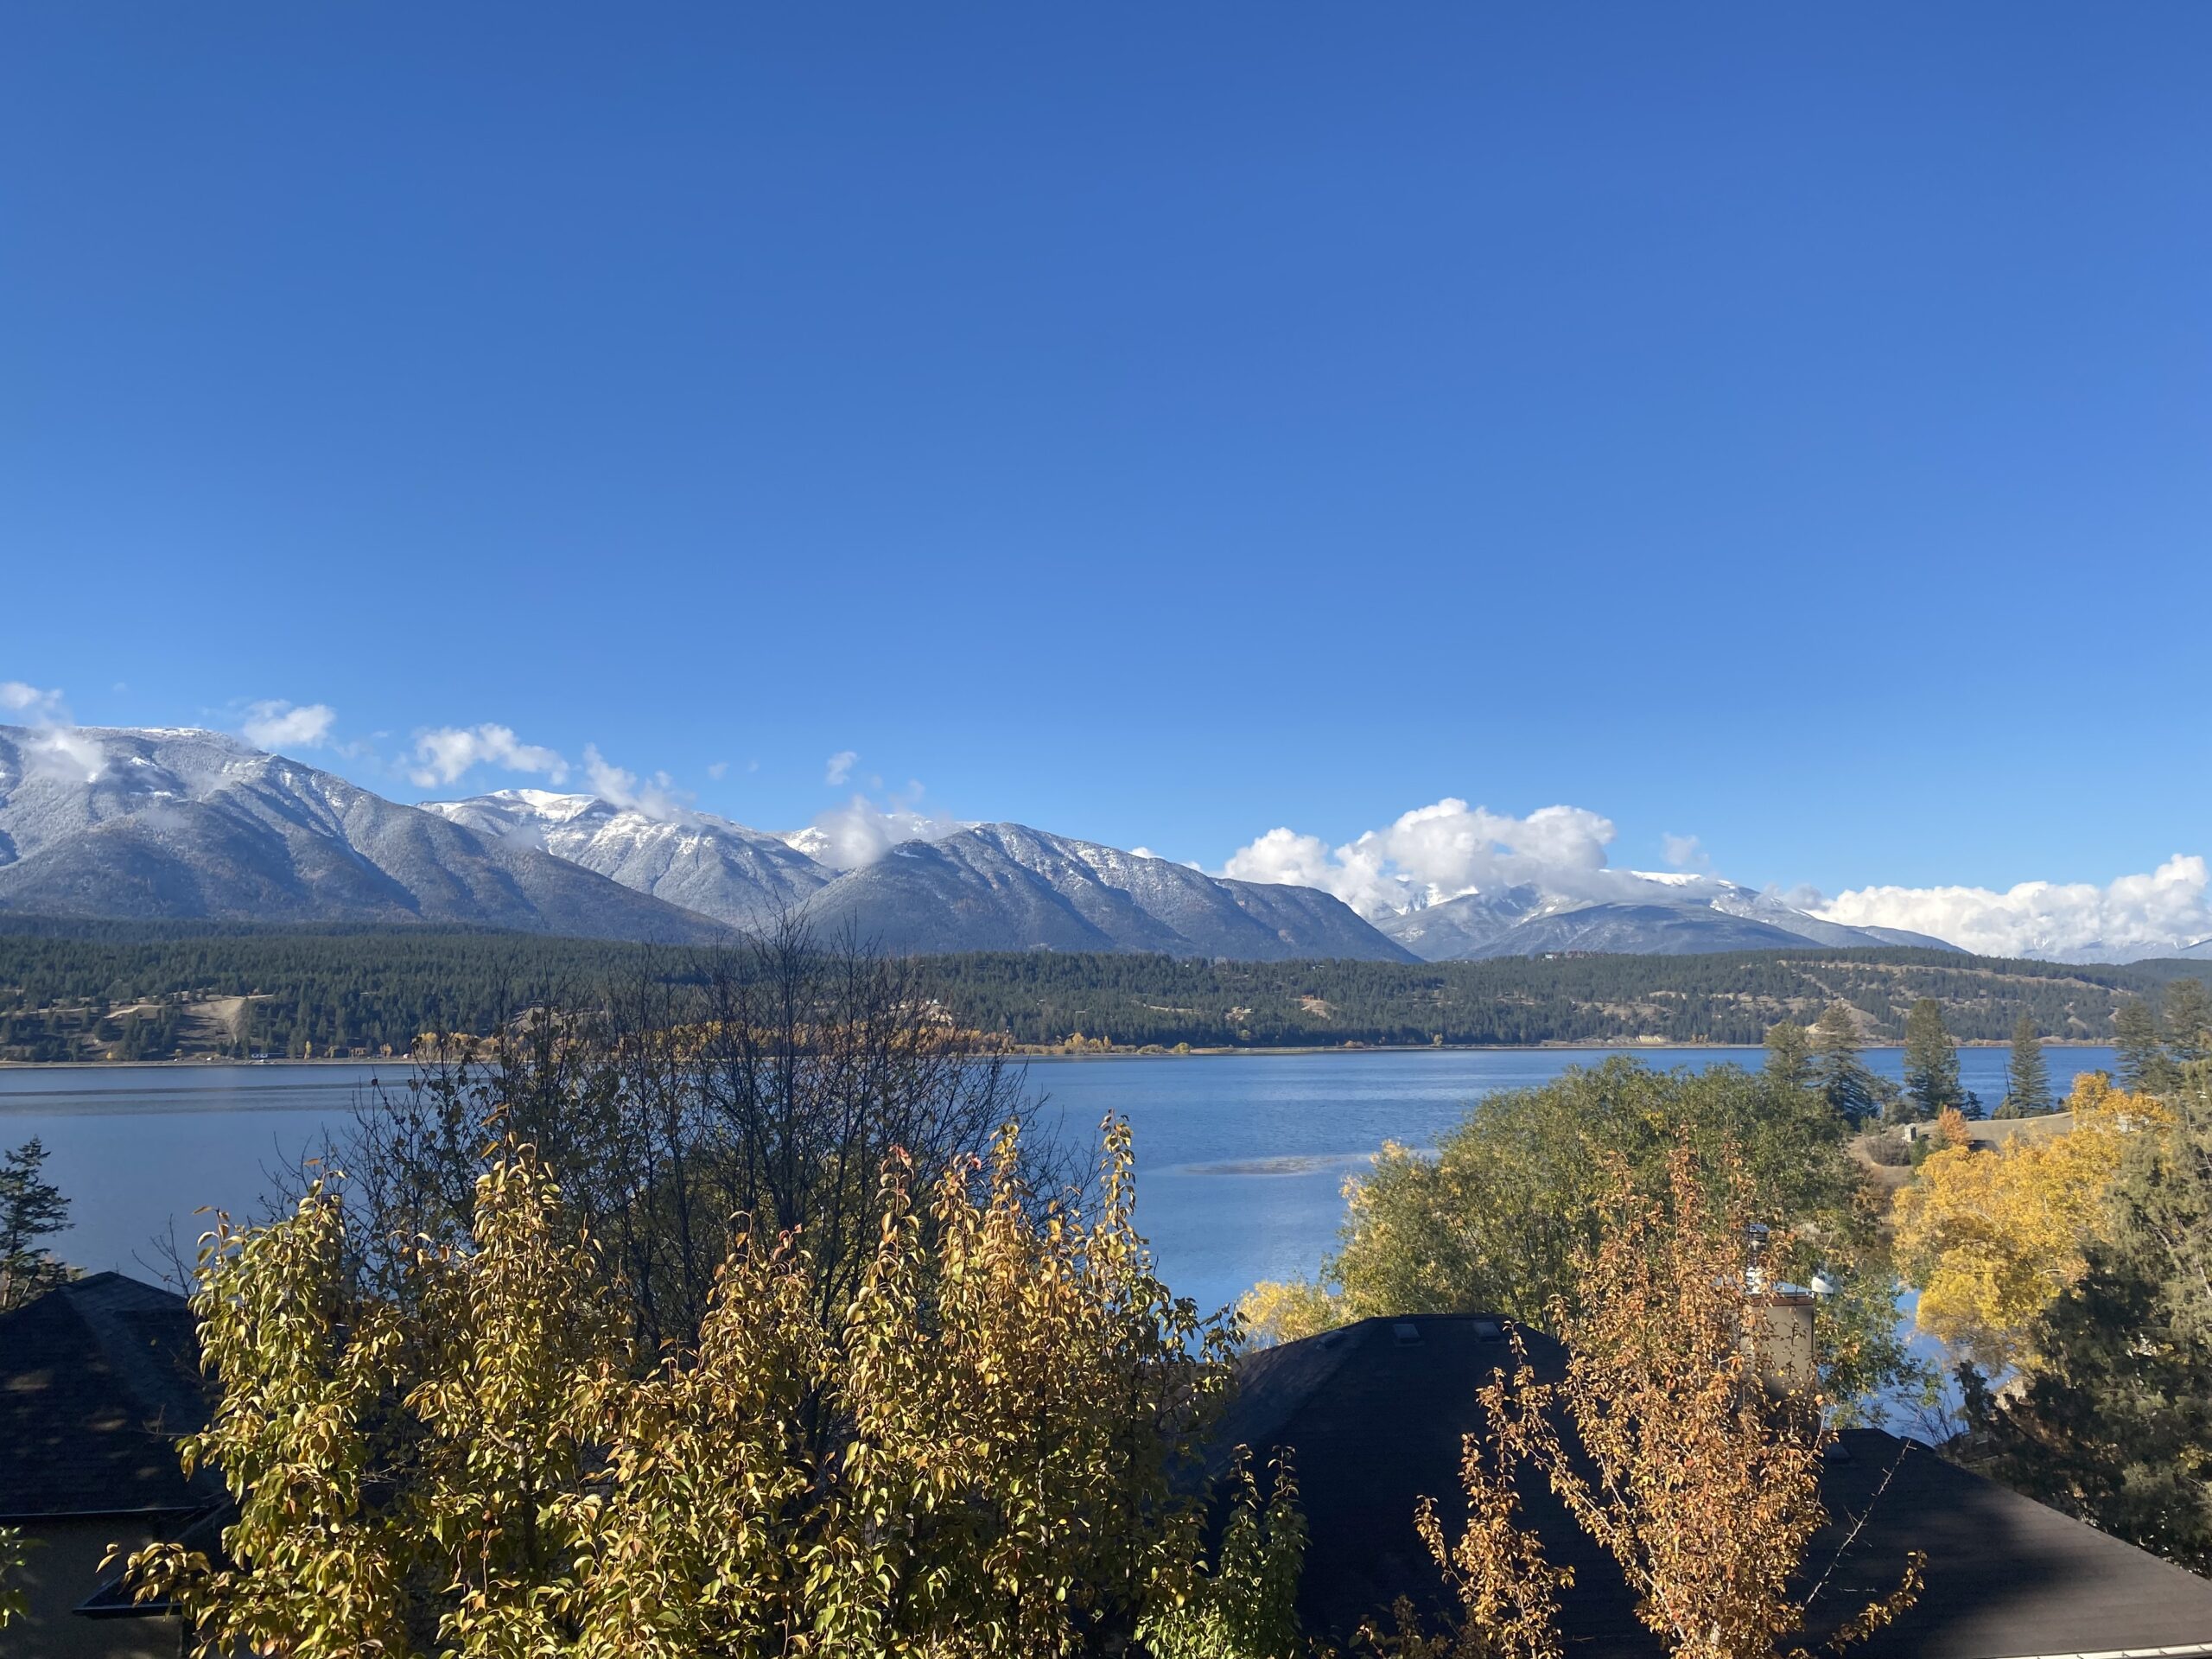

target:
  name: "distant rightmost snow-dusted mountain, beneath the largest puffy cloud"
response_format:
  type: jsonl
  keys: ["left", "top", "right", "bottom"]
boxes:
{"left": 1374, "top": 872, "right": 1955, "bottom": 963}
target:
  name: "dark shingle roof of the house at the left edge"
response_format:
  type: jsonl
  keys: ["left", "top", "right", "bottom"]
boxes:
{"left": 0, "top": 1272, "right": 214, "bottom": 1520}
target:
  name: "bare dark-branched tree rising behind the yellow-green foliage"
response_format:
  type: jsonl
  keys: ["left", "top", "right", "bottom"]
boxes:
{"left": 323, "top": 918, "right": 1035, "bottom": 1354}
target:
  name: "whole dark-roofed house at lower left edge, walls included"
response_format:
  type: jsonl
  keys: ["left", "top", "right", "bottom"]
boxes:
{"left": 0, "top": 1274, "right": 221, "bottom": 1659}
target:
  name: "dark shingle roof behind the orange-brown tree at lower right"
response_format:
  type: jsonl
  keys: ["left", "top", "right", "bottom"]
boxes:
{"left": 1219, "top": 1316, "right": 2212, "bottom": 1659}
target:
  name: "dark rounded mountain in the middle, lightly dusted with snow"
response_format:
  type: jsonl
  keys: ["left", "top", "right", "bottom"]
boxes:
{"left": 805, "top": 823, "right": 1411, "bottom": 963}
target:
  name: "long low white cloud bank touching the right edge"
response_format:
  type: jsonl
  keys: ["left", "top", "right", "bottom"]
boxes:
{"left": 1814, "top": 854, "right": 2212, "bottom": 963}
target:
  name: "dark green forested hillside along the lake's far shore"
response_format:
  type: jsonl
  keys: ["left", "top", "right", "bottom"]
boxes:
{"left": 0, "top": 923, "right": 2212, "bottom": 1059}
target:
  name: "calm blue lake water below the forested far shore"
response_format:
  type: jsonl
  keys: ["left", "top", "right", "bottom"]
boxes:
{"left": 0, "top": 1048, "right": 2113, "bottom": 1307}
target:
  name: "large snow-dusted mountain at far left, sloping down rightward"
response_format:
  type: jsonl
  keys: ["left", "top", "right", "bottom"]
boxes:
{"left": 0, "top": 726, "right": 723, "bottom": 943}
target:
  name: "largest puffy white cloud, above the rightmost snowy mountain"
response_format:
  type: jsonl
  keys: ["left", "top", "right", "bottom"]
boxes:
{"left": 1221, "top": 797, "right": 1635, "bottom": 916}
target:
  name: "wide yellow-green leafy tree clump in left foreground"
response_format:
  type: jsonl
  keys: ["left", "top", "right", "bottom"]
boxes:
{"left": 128, "top": 1126, "right": 1247, "bottom": 1659}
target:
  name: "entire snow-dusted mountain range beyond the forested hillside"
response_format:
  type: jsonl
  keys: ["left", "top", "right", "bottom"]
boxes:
{"left": 0, "top": 726, "right": 1991, "bottom": 963}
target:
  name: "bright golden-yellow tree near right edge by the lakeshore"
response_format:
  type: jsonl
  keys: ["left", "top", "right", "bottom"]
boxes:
{"left": 1896, "top": 1071, "right": 2170, "bottom": 1371}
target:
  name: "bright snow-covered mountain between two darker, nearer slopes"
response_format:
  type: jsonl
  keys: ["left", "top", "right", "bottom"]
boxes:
{"left": 423, "top": 790, "right": 834, "bottom": 929}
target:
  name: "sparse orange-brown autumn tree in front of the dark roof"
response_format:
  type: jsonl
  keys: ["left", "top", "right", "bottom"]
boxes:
{"left": 1400, "top": 1141, "right": 1923, "bottom": 1659}
